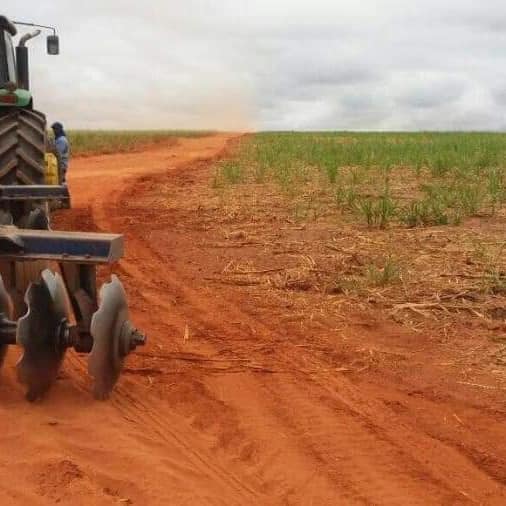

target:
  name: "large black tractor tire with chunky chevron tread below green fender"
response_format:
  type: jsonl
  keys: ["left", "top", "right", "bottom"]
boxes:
{"left": 0, "top": 108, "right": 46, "bottom": 185}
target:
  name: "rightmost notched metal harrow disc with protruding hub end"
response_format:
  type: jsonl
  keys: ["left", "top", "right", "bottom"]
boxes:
{"left": 88, "top": 275, "right": 146, "bottom": 400}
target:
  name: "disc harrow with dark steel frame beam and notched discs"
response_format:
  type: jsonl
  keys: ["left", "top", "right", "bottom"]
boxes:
{"left": 0, "top": 204, "right": 146, "bottom": 401}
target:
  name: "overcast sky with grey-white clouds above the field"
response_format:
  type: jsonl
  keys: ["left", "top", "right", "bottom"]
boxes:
{"left": 1, "top": 0, "right": 506, "bottom": 130}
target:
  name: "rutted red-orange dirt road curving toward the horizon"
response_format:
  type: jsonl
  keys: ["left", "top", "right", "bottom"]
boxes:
{"left": 0, "top": 135, "right": 506, "bottom": 505}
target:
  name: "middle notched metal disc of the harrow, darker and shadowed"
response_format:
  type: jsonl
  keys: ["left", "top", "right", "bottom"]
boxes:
{"left": 16, "top": 270, "right": 69, "bottom": 401}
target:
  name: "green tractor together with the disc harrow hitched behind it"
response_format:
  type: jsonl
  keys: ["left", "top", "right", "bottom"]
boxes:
{"left": 0, "top": 16, "right": 146, "bottom": 401}
